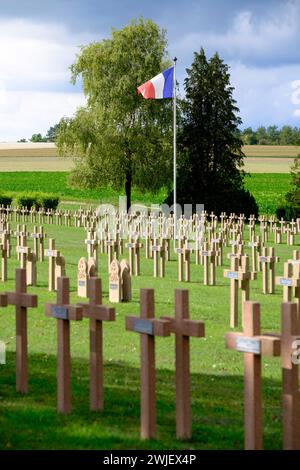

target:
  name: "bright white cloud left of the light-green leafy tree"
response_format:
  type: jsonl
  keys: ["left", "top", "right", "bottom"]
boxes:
{"left": 0, "top": 18, "right": 91, "bottom": 141}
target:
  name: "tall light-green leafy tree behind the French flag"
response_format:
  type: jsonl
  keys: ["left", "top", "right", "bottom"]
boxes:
{"left": 57, "top": 18, "right": 172, "bottom": 206}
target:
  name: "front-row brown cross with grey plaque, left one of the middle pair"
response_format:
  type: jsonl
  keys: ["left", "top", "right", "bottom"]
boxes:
{"left": 125, "top": 289, "right": 170, "bottom": 439}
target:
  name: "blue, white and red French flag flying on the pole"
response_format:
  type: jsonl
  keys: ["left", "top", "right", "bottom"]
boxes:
{"left": 137, "top": 65, "right": 174, "bottom": 100}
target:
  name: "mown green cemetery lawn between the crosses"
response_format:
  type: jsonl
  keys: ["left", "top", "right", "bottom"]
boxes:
{"left": 0, "top": 218, "right": 300, "bottom": 450}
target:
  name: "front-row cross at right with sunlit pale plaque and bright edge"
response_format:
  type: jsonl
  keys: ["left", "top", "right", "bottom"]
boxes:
{"left": 225, "top": 302, "right": 280, "bottom": 450}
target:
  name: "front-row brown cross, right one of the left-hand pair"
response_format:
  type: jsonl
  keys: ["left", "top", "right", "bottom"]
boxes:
{"left": 78, "top": 277, "right": 116, "bottom": 411}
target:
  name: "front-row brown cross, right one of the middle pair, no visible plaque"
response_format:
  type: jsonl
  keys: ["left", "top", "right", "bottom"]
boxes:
{"left": 161, "top": 289, "right": 205, "bottom": 439}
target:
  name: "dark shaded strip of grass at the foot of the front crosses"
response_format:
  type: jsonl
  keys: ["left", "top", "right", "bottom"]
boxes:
{"left": 0, "top": 353, "right": 281, "bottom": 449}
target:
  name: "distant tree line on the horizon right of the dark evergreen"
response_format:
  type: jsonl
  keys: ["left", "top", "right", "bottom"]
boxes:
{"left": 240, "top": 126, "right": 300, "bottom": 145}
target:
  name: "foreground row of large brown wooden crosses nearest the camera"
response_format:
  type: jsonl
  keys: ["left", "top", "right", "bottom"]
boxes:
{"left": 4, "top": 269, "right": 300, "bottom": 449}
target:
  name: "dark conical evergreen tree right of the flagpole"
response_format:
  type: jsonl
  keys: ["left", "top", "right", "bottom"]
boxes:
{"left": 167, "top": 49, "right": 257, "bottom": 214}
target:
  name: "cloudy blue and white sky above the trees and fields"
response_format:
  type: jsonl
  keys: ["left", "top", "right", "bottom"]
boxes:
{"left": 0, "top": 0, "right": 300, "bottom": 142}
